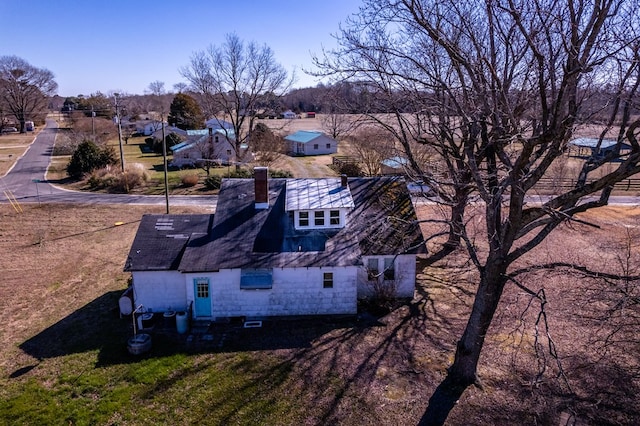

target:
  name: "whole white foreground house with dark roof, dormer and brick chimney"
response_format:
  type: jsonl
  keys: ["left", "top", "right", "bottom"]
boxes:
{"left": 125, "top": 167, "right": 425, "bottom": 320}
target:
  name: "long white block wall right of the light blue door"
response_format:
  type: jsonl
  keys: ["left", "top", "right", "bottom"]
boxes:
{"left": 186, "top": 267, "right": 358, "bottom": 318}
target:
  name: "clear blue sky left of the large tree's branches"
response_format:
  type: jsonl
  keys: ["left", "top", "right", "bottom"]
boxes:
{"left": 0, "top": 0, "right": 361, "bottom": 96}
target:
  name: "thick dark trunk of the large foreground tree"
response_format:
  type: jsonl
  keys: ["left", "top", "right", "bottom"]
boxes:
{"left": 419, "top": 262, "right": 506, "bottom": 425}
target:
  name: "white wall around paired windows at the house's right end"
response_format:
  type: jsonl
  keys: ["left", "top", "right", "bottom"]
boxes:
{"left": 358, "top": 254, "right": 416, "bottom": 298}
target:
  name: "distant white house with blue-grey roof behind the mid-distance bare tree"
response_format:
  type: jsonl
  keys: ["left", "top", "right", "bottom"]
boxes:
{"left": 170, "top": 127, "right": 236, "bottom": 168}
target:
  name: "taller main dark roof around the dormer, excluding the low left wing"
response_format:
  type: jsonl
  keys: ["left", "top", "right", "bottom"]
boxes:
{"left": 179, "top": 177, "right": 425, "bottom": 272}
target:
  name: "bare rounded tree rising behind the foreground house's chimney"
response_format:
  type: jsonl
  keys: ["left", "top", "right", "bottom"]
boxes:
{"left": 181, "top": 34, "right": 291, "bottom": 168}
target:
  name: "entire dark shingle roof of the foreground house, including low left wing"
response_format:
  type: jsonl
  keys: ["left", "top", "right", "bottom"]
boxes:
{"left": 125, "top": 177, "right": 426, "bottom": 272}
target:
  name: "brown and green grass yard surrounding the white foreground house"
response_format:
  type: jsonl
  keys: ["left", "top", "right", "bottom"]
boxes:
{"left": 0, "top": 204, "right": 640, "bottom": 426}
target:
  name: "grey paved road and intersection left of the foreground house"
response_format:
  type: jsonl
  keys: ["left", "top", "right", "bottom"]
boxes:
{"left": 0, "top": 119, "right": 217, "bottom": 208}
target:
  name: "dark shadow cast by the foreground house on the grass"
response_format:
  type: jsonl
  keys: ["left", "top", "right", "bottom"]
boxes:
{"left": 11, "top": 290, "right": 375, "bottom": 377}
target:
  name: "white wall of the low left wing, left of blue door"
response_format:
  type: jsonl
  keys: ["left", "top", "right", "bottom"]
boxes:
{"left": 132, "top": 271, "right": 188, "bottom": 312}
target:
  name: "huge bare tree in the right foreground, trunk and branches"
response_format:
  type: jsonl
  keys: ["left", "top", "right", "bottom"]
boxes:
{"left": 318, "top": 0, "right": 640, "bottom": 424}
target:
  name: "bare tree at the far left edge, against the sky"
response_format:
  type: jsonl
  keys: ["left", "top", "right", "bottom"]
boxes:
{"left": 0, "top": 56, "right": 58, "bottom": 133}
